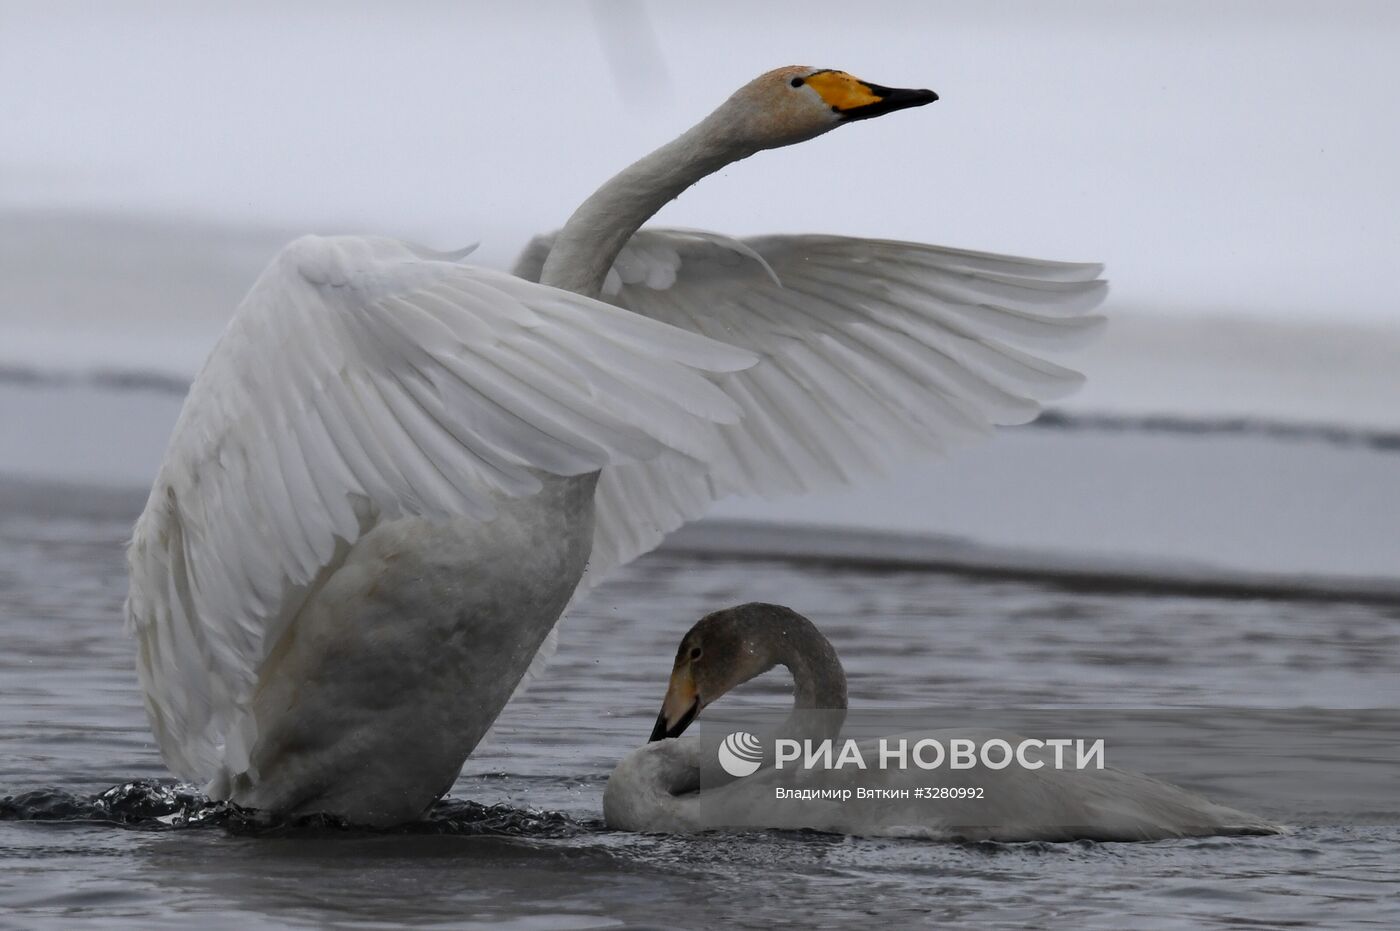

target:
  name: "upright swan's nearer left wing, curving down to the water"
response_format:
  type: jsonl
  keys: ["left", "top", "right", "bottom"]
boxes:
{"left": 127, "top": 237, "right": 755, "bottom": 780}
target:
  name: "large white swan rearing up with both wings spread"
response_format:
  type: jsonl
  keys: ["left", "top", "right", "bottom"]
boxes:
{"left": 127, "top": 67, "right": 1105, "bottom": 823}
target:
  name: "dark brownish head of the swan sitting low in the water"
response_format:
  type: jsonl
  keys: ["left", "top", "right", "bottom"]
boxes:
{"left": 651, "top": 602, "right": 828, "bottom": 741}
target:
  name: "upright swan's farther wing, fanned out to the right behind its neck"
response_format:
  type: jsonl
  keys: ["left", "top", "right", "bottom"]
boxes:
{"left": 515, "top": 230, "right": 1107, "bottom": 592}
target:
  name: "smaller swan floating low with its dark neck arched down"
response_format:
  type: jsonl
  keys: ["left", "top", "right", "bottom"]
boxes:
{"left": 603, "top": 603, "right": 1280, "bottom": 841}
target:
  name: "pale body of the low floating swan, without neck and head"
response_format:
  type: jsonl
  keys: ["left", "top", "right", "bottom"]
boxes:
{"left": 603, "top": 728, "right": 1278, "bottom": 843}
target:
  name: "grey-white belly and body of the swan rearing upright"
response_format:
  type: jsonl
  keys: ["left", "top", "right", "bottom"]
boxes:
{"left": 211, "top": 477, "right": 592, "bottom": 825}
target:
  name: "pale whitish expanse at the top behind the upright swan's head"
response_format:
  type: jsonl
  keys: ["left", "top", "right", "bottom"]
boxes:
{"left": 0, "top": 0, "right": 1400, "bottom": 321}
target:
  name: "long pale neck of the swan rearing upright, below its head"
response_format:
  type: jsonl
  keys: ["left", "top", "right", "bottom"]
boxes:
{"left": 539, "top": 108, "right": 757, "bottom": 297}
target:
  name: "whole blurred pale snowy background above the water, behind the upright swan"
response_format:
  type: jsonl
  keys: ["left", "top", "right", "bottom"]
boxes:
{"left": 0, "top": 0, "right": 1400, "bottom": 577}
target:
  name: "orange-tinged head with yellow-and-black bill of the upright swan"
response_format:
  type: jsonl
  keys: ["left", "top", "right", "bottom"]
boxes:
{"left": 714, "top": 64, "right": 938, "bottom": 151}
